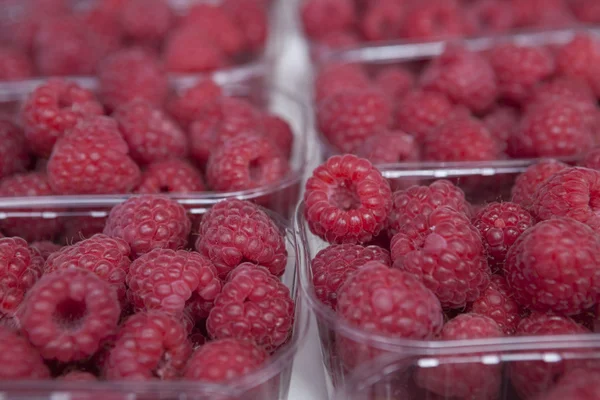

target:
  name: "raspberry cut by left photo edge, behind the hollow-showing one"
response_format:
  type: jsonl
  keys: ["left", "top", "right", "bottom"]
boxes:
{"left": 0, "top": 237, "right": 44, "bottom": 316}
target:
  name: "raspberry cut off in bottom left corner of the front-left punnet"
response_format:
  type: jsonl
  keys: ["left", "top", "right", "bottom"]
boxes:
{"left": 0, "top": 326, "right": 50, "bottom": 382}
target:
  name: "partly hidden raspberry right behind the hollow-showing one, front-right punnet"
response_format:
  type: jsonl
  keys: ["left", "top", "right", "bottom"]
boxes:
{"left": 388, "top": 179, "right": 471, "bottom": 237}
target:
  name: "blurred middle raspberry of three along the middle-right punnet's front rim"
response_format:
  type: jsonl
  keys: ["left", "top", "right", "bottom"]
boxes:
{"left": 423, "top": 117, "right": 501, "bottom": 161}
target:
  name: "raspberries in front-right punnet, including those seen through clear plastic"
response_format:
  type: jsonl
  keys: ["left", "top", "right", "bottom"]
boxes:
{"left": 304, "top": 152, "right": 600, "bottom": 400}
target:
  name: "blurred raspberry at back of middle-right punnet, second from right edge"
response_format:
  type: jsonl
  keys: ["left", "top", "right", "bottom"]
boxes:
{"left": 490, "top": 44, "right": 556, "bottom": 104}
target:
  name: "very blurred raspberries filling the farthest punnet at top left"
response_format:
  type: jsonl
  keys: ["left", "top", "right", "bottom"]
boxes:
{"left": 0, "top": 0, "right": 268, "bottom": 81}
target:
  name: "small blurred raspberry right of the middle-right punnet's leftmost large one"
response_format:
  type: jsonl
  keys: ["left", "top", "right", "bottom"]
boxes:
{"left": 396, "top": 89, "right": 454, "bottom": 142}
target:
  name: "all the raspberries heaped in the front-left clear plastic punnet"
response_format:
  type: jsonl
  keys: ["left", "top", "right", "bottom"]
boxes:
{"left": 0, "top": 195, "right": 295, "bottom": 383}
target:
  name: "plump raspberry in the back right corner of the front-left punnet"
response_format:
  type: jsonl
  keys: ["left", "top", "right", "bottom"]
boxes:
{"left": 196, "top": 199, "right": 287, "bottom": 279}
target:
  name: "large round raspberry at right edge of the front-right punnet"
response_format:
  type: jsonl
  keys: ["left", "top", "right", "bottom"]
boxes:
{"left": 504, "top": 218, "right": 600, "bottom": 315}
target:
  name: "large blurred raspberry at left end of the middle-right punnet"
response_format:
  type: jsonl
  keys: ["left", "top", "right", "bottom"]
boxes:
{"left": 317, "top": 89, "right": 392, "bottom": 153}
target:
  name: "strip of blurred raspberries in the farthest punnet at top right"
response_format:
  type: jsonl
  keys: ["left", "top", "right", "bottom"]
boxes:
{"left": 300, "top": 0, "right": 600, "bottom": 49}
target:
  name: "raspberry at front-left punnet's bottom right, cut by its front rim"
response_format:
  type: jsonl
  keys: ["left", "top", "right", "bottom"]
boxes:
{"left": 185, "top": 339, "right": 269, "bottom": 382}
